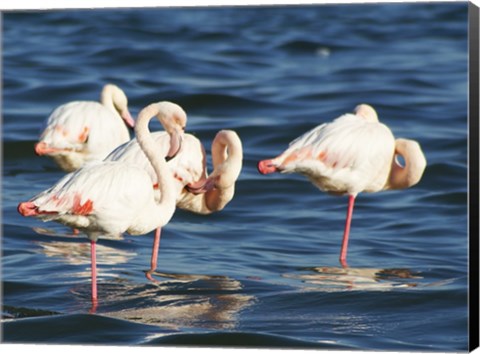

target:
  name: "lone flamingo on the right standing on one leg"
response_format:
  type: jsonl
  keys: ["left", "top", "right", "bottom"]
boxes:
{"left": 258, "top": 104, "right": 427, "bottom": 268}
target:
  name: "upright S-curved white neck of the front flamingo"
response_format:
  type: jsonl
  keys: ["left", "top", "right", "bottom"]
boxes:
{"left": 135, "top": 103, "right": 176, "bottom": 218}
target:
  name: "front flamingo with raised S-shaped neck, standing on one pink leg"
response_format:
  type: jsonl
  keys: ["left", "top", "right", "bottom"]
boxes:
{"left": 18, "top": 103, "right": 182, "bottom": 304}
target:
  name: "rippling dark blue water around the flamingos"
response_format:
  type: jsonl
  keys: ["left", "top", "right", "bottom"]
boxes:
{"left": 2, "top": 3, "right": 468, "bottom": 351}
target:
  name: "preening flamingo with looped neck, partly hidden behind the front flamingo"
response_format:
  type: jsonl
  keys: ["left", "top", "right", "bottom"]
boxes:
{"left": 105, "top": 121, "right": 243, "bottom": 281}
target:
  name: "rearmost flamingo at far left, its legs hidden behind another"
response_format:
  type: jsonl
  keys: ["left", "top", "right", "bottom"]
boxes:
{"left": 35, "top": 84, "right": 135, "bottom": 172}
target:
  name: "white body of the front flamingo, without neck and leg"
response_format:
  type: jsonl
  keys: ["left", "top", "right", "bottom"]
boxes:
{"left": 19, "top": 162, "right": 175, "bottom": 241}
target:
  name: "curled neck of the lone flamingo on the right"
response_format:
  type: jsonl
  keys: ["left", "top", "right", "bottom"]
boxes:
{"left": 386, "top": 139, "right": 427, "bottom": 189}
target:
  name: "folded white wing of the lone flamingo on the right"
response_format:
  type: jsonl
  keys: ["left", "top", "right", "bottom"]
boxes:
{"left": 279, "top": 114, "right": 394, "bottom": 194}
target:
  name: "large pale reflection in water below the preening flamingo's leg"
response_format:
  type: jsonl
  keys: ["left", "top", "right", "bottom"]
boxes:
{"left": 99, "top": 272, "right": 256, "bottom": 330}
